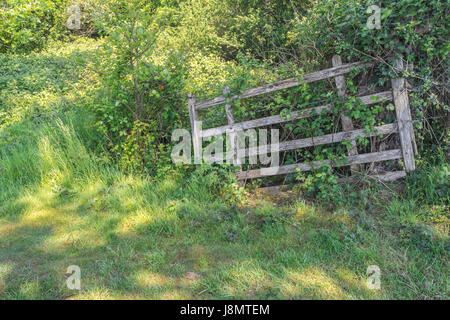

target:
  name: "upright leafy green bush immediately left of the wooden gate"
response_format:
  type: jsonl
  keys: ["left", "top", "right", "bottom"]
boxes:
{"left": 94, "top": 1, "right": 188, "bottom": 173}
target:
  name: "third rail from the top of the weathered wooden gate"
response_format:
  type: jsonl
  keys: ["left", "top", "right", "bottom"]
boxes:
{"left": 206, "top": 123, "right": 398, "bottom": 162}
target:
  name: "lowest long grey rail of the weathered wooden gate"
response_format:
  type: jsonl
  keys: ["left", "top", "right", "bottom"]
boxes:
{"left": 236, "top": 149, "right": 402, "bottom": 180}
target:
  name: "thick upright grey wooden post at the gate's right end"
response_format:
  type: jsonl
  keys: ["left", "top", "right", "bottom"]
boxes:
{"left": 391, "top": 59, "right": 416, "bottom": 172}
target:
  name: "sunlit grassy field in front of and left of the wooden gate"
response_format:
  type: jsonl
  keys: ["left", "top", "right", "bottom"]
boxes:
{"left": 0, "top": 43, "right": 450, "bottom": 299}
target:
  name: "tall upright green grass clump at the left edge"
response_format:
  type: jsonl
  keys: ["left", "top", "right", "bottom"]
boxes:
{"left": 0, "top": 113, "right": 101, "bottom": 215}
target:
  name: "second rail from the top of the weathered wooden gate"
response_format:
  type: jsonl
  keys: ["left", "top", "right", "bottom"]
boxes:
{"left": 201, "top": 91, "right": 392, "bottom": 137}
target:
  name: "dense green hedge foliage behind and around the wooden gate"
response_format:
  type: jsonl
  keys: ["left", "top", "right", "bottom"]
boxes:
{"left": 0, "top": 0, "right": 450, "bottom": 192}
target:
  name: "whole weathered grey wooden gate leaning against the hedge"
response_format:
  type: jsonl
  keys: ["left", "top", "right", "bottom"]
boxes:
{"left": 189, "top": 55, "right": 417, "bottom": 185}
